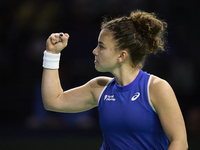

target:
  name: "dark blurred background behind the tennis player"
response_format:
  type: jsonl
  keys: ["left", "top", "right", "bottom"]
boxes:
{"left": 0, "top": 0, "right": 200, "bottom": 150}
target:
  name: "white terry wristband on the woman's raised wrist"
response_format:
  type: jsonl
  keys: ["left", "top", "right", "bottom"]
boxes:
{"left": 42, "top": 51, "right": 60, "bottom": 69}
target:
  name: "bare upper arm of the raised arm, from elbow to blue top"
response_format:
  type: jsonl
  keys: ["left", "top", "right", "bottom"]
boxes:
{"left": 47, "top": 77, "right": 111, "bottom": 113}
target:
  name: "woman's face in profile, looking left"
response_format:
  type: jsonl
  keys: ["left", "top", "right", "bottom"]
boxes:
{"left": 93, "top": 30, "right": 120, "bottom": 73}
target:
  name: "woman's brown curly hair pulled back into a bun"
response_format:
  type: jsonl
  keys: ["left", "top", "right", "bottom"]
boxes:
{"left": 101, "top": 10, "right": 167, "bottom": 68}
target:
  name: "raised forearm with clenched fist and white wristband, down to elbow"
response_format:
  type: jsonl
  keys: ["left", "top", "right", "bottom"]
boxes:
{"left": 42, "top": 33, "right": 69, "bottom": 110}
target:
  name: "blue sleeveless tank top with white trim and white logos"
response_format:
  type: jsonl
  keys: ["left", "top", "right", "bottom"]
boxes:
{"left": 98, "top": 70, "right": 169, "bottom": 150}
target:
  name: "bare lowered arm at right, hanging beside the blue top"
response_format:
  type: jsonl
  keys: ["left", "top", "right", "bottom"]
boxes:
{"left": 149, "top": 77, "right": 188, "bottom": 150}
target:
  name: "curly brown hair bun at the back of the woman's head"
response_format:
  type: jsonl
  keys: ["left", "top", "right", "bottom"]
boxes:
{"left": 130, "top": 10, "right": 167, "bottom": 53}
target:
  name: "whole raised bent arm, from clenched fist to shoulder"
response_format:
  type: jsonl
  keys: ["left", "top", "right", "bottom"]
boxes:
{"left": 42, "top": 33, "right": 109, "bottom": 113}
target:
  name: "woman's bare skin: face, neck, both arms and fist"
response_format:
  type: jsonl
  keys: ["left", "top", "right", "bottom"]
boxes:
{"left": 42, "top": 30, "right": 188, "bottom": 150}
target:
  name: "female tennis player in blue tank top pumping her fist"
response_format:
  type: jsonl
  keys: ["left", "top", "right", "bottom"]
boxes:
{"left": 42, "top": 10, "right": 188, "bottom": 150}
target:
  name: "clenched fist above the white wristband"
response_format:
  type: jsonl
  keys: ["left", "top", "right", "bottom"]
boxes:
{"left": 46, "top": 33, "right": 69, "bottom": 54}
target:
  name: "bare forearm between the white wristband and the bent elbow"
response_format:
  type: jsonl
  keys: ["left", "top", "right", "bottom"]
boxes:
{"left": 42, "top": 68, "right": 63, "bottom": 109}
